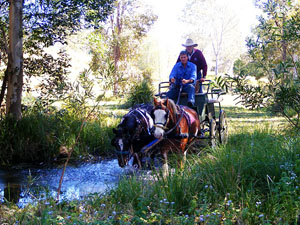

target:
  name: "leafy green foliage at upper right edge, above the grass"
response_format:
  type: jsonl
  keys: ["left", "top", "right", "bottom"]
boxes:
{"left": 230, "top": 0, "right": 300, "bottom": 119}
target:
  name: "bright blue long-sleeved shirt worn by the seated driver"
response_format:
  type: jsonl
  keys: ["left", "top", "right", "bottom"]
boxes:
{"left": 169, "top": 62, "right": 197, "bottom": 85}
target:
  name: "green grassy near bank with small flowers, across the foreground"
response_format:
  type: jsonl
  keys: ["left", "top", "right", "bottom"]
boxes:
{"left": 0, "top": 108, "right": 300, "bottom": 224}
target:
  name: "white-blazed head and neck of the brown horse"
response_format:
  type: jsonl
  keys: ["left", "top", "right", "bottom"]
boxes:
{"left": 151, "top": 98, "right": 178, "bottom": 138}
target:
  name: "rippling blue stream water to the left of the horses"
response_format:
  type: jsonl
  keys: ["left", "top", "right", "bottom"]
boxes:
{"left": 0, "top": 160, "right": 126, "bottom": 207}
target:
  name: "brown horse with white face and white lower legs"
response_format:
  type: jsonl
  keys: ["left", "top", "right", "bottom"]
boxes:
{"left": 151, "top": 98, "right": 200, "bottom": 177}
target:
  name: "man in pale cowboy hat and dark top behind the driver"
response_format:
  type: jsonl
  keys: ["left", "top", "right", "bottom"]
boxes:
{"left": 177, "top": 38, "right": 207, "bottom": 92}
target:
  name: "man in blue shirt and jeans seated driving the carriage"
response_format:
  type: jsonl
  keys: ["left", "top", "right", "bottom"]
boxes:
{"left": 167, "top": 51, "right": 197, "bottom": 107}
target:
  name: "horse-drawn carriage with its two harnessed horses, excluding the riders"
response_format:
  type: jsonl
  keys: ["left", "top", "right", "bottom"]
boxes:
{"left": 112, "top": 80, "right": 228, "bottom": 174}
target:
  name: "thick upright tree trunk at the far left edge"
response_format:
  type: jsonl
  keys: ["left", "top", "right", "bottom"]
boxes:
{"left": 6, "top": 0, "right": 23, "bottom": 120}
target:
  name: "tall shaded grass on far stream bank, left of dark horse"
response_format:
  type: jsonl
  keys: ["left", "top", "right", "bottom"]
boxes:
{"left": 0, "top": 107, "right": 120, "bottom": 165}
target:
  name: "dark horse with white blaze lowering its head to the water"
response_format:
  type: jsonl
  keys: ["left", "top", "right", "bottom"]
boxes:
{"left": 111, "top": 104, "right": 155, "bottom": 168}
